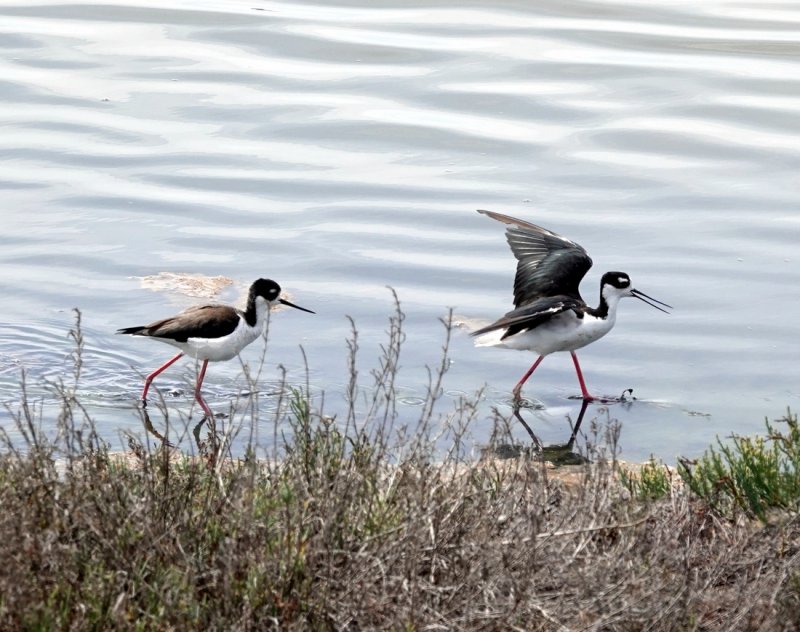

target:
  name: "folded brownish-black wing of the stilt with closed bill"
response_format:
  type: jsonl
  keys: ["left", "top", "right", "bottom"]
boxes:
{"left": 117, "top": 305, "right": 239, "bottom": 342}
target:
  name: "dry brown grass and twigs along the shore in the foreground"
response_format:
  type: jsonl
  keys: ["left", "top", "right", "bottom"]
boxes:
{"left": 0, "top": 307, "right": 800, "bottom": 631}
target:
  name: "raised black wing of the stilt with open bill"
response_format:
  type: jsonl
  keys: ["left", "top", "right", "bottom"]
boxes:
{"left": 478, "top": 211, "right": 592, "bottom": 307}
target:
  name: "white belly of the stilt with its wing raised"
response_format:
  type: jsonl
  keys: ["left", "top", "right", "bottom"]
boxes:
{"left": 475, "top": 310, "right": 614, "bottom": 355}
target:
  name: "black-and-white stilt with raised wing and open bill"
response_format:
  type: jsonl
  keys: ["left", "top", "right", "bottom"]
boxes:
{"left": 472, "top": 211, "right": 672, "bottom": 401}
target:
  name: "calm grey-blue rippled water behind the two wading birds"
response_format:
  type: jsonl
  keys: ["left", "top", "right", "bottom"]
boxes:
{"left": 0, "top": 0, "right": 800, "bottom": 460}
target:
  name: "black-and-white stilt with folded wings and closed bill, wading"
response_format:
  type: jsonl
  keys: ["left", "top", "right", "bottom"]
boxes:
{"left": 117, "top": 279, "right": 314, "bottom": 417}
